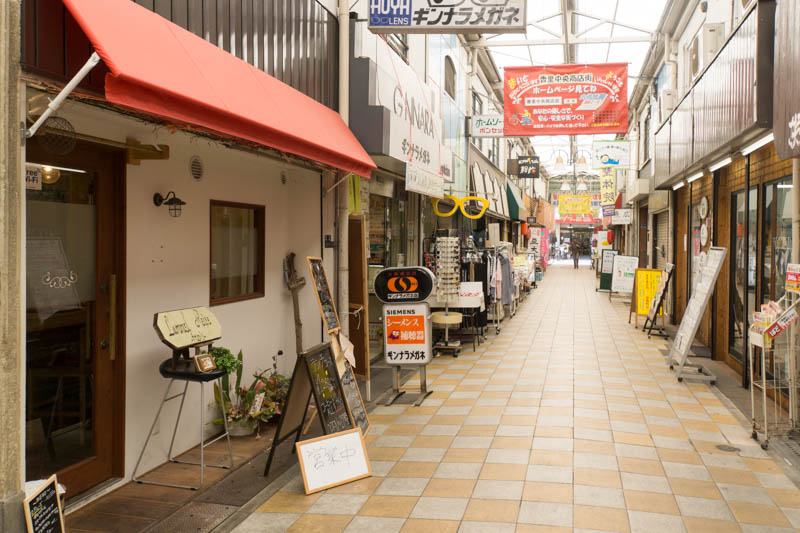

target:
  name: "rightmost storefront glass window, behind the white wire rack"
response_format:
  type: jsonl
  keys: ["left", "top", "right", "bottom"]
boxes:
{"left": 761, "top": 178, "right": 792, "bottom": 303}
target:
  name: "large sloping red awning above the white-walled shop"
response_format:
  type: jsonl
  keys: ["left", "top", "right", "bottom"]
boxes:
{"left": 63, "top": 0, "right": 375, "bottom": 177}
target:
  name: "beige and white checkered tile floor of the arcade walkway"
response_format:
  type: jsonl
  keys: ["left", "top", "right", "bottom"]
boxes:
{"left": 230, "top": 267, "right": 800, "bottom": 533}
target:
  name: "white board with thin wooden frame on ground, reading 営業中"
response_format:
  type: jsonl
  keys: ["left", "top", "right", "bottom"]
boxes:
{"left": 295, "top": 428, "right": 372, "bottom": 494}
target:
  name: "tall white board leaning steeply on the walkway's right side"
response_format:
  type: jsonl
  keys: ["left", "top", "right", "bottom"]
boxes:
{"left": 668, "top": 246, "right": 728, "bottom": 377}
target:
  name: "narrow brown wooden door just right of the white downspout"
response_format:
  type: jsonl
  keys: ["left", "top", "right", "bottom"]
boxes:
{"left": 348, "top": 215, "right": 370, "bottom": 381}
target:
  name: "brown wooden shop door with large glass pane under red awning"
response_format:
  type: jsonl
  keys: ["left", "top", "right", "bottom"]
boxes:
{"left": 25, "top": 138, "right": 125, "bottom": 497}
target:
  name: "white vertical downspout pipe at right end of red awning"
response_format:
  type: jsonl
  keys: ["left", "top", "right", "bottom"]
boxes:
{"left": 334, "top": 0, "right": 350, "bottom": 335}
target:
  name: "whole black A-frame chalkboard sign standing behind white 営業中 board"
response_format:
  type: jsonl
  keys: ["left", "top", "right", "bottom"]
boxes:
{"left": 264, "top": 342, "right": 353, "bottom": 476}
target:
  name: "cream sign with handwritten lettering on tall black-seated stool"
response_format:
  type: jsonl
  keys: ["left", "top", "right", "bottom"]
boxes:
{"left": 153, "top": 307, "right": 222, "bottom": 350}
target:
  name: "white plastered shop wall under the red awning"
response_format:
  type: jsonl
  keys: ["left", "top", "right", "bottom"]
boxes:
{"left": 48, "top": 96, "right": 335, "bottom": 477}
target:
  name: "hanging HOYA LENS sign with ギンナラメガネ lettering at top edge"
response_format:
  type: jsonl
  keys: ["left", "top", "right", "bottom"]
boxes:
{"left": 369, "top": 0, "right": 526, "bottom": 33}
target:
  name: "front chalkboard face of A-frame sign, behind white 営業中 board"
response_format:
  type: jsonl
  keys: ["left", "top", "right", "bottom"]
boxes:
{"left": 305, "top": 343, "right": 353, "bottom": 435}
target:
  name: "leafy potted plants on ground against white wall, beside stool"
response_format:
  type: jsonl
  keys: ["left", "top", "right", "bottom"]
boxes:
{"left": 211, "top": 347, "right": 289, "bottom": 436}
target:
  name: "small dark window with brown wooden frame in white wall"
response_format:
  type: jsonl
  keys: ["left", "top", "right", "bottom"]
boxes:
{"left": 209, "top": 200, "right": 266, "bottom": 305}
